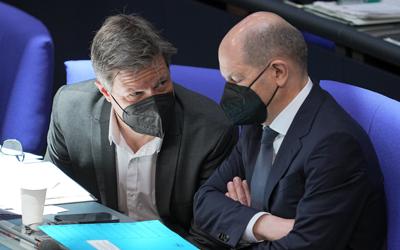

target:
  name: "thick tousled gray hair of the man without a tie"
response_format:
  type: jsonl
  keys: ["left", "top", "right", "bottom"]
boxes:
{"left": 91, "top": 14, "right": 176, "bottom": 90}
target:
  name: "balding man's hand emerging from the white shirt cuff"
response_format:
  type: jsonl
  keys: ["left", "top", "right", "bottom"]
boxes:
{"left": 253, "top": 214, "right": 295, "bottom": 241}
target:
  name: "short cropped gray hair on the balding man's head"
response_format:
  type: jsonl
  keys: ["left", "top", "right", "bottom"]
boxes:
{"left": 243, "top": 23, "right": 307, "bottom": 71}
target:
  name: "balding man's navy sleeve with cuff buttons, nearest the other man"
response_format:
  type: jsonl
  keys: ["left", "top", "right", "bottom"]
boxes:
{"left": 194, "top": 129, "right": 257, "bottom": 246}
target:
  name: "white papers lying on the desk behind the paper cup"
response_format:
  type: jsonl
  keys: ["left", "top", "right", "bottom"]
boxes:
{"left": 0, "top": 157, "right": 96, "bottom": 211}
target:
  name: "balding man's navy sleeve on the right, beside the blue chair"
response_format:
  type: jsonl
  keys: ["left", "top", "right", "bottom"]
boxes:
{"left": 250, "top": 133, "right": 382, "bottom": 250}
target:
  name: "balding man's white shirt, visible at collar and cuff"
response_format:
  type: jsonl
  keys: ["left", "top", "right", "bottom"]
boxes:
{"left": 242, "top": 78, "right": 313, "bottom": 242}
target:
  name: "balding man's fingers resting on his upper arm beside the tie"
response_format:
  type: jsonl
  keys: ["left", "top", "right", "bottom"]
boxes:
{"left": 225, "top": 176, "right": 251, "bottom": 207}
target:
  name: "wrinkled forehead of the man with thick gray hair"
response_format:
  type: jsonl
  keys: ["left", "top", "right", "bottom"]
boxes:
{"left": 114, "top": 59, "right": 169, "bottom": 87}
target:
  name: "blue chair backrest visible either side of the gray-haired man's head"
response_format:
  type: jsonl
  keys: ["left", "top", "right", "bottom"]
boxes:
{"left": 64, "top": 60, "right": 225, "bottom": 102}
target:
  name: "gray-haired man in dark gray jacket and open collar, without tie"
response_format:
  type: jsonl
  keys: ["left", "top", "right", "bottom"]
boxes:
{"left": 46, "top": 15, "right": 237, "bottom": 240}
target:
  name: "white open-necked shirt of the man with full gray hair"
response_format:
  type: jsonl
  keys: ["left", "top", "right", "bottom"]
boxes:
{"left": 108, "top": 109, "right": 162, "bottom": 221}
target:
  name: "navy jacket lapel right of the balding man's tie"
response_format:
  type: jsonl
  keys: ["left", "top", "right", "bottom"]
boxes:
{"left": 265, "top": 84, "right": 323, "bottom": 210}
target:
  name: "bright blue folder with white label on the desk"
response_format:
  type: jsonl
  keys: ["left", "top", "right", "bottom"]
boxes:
{"left": 39, "top": 220, "right": 197, "bottom": 250}
